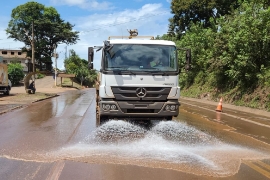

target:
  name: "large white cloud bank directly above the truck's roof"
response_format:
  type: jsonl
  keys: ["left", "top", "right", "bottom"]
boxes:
{"left": 61, "top": 4, "right": 170, "bottom": 69}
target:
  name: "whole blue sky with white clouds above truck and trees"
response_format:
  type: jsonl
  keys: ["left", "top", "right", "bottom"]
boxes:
{"left": 0, "top": 0, "right": 173, "bottom": 70}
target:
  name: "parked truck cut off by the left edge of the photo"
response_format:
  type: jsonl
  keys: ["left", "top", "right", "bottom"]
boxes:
{"left": 0, "top": 63, "right": 12, "bottom": 95}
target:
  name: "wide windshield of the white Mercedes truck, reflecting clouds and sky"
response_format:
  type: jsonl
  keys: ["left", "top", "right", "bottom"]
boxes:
{"left": 104, "top": 44, "right": 178, "bottom": 72}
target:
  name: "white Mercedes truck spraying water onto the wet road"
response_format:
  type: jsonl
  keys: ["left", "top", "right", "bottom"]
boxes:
{"left": 88, "top": 30, "right": 191, "bottom": 125}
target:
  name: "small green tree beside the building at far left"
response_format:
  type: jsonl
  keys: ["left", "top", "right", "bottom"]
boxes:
{"left": 8, "top": 63, "right": 24, "bottom": 85}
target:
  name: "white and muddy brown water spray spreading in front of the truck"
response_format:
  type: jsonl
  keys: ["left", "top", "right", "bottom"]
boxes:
{"left": 46, "top": 121, "right": 270, "bottom": 176}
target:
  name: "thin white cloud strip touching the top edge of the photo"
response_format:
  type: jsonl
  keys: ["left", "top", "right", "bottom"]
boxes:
{"left": 50, "top": 0, "right": 113, "bottom": 10}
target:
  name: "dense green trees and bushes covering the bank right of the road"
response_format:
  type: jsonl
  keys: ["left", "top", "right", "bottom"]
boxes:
{"left": 157, "top": 0, "right": 270, "bottom": 111}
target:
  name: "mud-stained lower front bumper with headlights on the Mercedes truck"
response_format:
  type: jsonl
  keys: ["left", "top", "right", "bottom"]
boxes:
{"left": 99, "top": 100, "right": 180, "bottom": 119}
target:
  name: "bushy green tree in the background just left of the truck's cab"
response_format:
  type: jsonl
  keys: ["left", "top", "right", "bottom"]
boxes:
{"left": 64, "top": 50, "right": 97, "bottom": 86}
